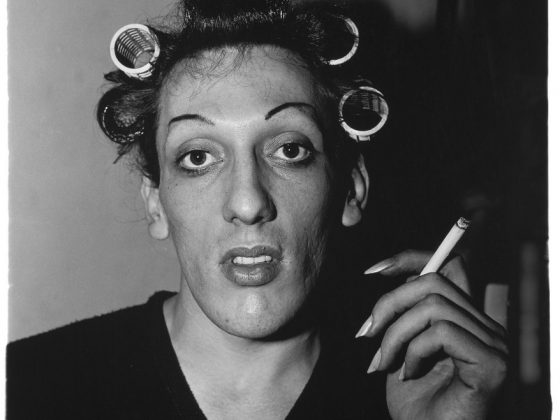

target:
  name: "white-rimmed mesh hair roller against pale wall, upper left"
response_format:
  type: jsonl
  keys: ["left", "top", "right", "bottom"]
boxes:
{"left": 110, "top": 23, "right": 160, "bottom": 80}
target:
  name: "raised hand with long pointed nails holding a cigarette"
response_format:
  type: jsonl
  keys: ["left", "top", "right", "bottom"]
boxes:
{"left": 358, "top": 251, "right": 508, "bottom": 420}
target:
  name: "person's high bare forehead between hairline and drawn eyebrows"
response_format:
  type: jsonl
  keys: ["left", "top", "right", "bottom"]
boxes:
{"left": 160, "top": 46, "right": 319, "bottom": 123}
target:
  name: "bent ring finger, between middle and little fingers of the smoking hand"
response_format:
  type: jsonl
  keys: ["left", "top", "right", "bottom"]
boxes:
{"left": 377, "top": 294, "right": 508, "bottom": 370}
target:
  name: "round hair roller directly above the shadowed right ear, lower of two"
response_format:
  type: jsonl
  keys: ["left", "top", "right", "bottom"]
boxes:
{"left": 338, "top": 84, "right": 389, "bottom": 141}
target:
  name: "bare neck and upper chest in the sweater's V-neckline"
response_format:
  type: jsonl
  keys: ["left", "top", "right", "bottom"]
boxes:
{"left": 164, "top": 286, "right": 319, "bottom": 420}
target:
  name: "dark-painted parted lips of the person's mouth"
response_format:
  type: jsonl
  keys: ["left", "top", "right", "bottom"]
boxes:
{"left": 220, "top": 245, "right": 282, "bottom": 287}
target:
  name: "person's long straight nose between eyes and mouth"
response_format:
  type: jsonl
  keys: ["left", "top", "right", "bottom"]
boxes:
{"left": 223, "top": 159, "right": 276, "bottom": 225}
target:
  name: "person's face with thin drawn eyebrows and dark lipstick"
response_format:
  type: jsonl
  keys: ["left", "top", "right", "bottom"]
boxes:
{"left": 153, "top": 47, "right": 340, "bottom": 338}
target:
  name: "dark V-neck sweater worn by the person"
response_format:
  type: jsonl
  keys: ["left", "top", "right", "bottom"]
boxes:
{"left": 7, "top": 292, "right": 388, "bottom": 420}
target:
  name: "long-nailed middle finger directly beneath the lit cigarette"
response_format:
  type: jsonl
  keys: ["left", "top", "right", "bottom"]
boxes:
{"left": 361, "top": 273, "right": 505, "bottom": 337}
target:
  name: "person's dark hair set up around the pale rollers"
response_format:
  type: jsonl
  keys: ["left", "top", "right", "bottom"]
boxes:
{"left": 97, "top": 0, "right": 356, "bottom": 185}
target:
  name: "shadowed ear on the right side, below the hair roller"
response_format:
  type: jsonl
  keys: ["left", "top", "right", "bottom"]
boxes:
{"left": 342, "top": 153, "right": 369, "bottom": 227}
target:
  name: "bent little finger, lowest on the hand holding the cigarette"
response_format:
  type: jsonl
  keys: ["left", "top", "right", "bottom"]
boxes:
{"left": 401, "top": 321, "right": 507, "bottom": 389}
